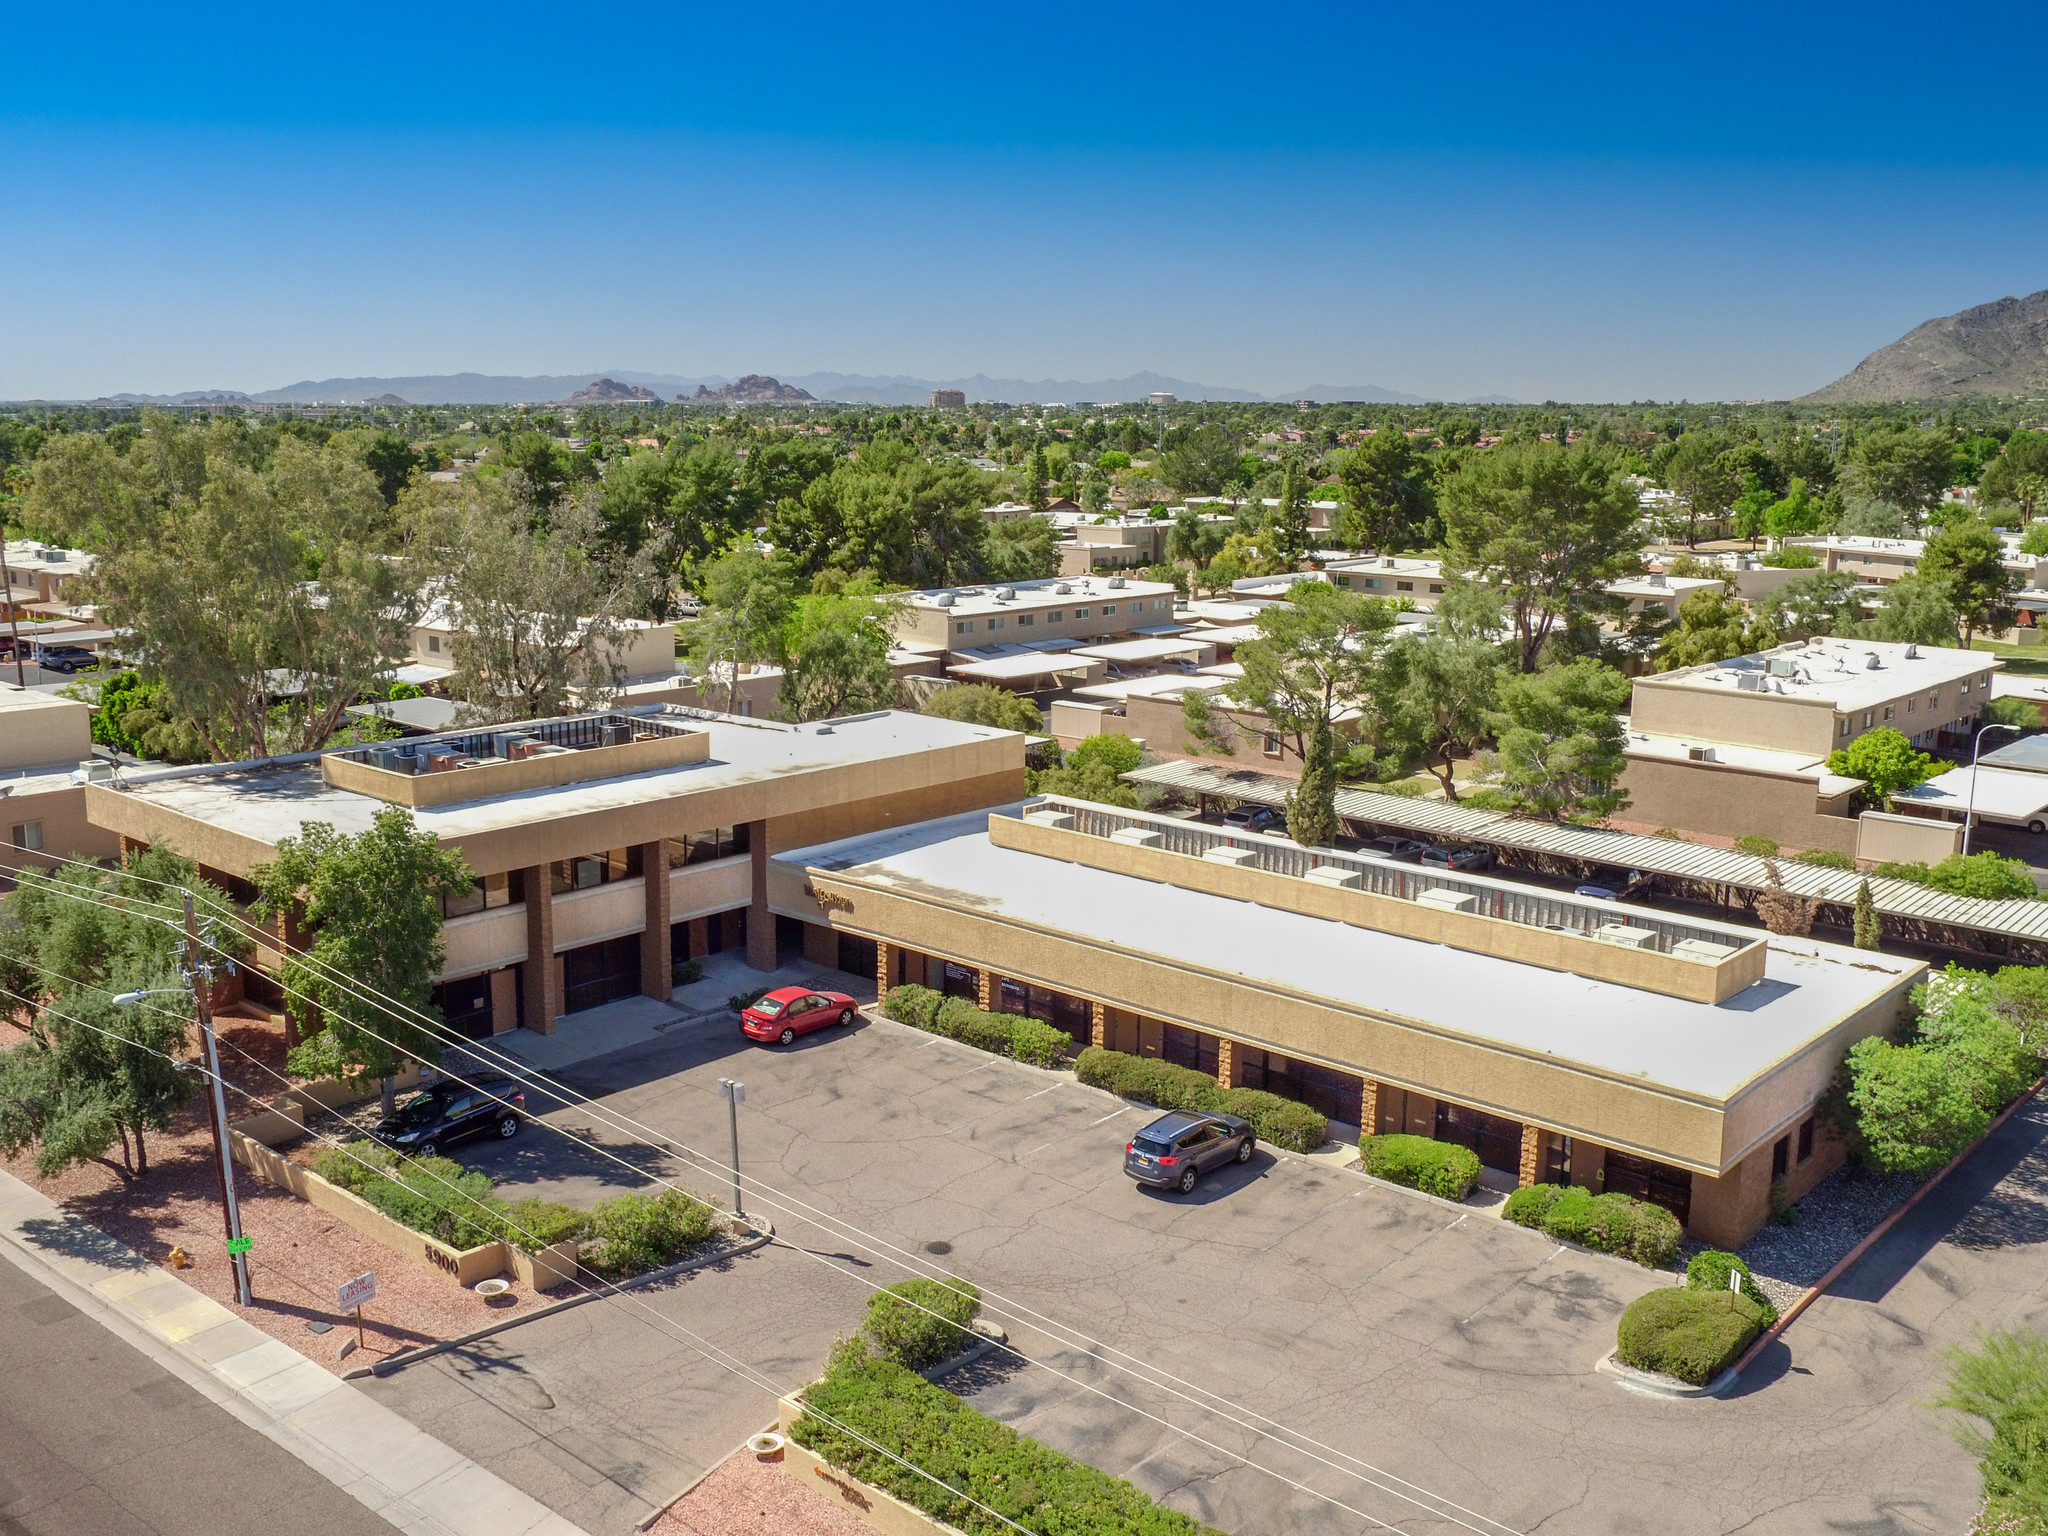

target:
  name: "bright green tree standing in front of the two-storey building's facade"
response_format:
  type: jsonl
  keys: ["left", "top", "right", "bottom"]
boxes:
{"left": 250, "top": 805, "right": 473, "bottom": 1114}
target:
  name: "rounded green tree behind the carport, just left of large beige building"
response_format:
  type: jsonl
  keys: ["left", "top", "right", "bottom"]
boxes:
{"left": 1485, "top": 657, "right": 1630, "bottom": 821}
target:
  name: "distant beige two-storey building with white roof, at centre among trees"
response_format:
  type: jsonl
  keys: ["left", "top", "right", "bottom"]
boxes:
{"left": 897, "top": 575, "right": 1174, "bottom": 651}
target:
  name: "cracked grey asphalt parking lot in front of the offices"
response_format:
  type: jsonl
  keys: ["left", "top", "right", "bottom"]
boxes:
{"left": 365, "top": 1020, "right": 2048, "bottom": 1536}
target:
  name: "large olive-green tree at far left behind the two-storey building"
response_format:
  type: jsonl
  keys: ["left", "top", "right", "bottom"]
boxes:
{"left": 27, "top": 412, "right": 414, "bottom": 762}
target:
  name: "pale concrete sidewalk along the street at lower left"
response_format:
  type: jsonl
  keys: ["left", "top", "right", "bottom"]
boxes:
{"left": 0, "top": 1174, "right": 584, "bottom": 1536}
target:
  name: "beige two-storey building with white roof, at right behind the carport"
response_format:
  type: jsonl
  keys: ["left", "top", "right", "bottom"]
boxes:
{"left": 1622, "top": 639, "right": 2003, "bottom": 854}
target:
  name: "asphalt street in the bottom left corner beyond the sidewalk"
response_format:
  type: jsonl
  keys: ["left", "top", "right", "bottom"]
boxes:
{"left": 0, "top": 1257, "right": 393, "bottom": 1536}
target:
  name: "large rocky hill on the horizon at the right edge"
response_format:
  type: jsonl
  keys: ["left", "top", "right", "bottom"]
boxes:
{"left": 1806, "top": 289, "right": 2048, "bottom": 403}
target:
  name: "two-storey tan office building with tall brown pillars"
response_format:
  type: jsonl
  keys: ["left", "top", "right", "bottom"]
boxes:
{"left": 84, "top": 707, "right": 1024, "bottom": 1036}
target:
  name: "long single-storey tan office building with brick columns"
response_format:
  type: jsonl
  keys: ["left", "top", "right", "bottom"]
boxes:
{"left": 768, "top": 799, "right": 1925, "bottom": 1247}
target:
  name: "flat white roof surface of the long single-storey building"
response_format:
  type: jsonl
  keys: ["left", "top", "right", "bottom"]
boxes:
{"left": 776, "top": 813, "right": 1919, "bottom": 1102}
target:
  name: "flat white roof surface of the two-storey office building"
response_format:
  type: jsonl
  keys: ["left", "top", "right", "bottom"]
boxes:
{"left": 103, "top": 711, "right": 1016, "bottom": 844}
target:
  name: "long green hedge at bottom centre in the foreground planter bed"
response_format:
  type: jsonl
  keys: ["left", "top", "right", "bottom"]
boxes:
{"left": 791, "top": 1354, "right": 1221, "bottom": 1536}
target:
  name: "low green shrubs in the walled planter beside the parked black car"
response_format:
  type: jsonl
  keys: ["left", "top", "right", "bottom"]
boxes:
{"left": 307, "top": 1141, "right": 719, "bottom": 1280}
